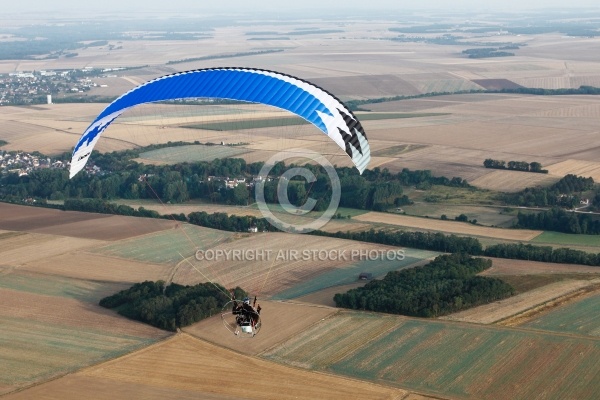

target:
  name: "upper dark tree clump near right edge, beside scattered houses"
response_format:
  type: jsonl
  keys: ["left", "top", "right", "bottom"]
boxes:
{"left": 503, "top": 174, "right": 600, "bottom": 208}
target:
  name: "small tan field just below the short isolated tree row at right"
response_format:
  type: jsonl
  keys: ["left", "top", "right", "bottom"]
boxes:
{"left": 469, "top": 170, "right": 559, "bottom": 192}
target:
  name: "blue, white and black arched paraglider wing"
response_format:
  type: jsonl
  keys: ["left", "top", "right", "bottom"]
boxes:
{"left": 69, "top": 68, "right": 371, "bottom": 178}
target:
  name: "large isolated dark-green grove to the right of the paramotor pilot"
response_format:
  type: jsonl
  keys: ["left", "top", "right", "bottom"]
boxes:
{"left": 334, "top": 253, "right": 515, "bottom": 317}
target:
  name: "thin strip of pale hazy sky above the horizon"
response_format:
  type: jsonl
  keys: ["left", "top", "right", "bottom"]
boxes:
{"left": 0, "top": 0, "right": 599, "bottom": 14}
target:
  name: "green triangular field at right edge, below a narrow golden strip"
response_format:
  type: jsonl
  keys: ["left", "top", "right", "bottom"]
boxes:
{"left": 522, "top": 294, "right": 600, "bottom": 336}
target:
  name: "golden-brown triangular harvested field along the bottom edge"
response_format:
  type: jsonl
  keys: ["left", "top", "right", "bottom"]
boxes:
{"left": 7, "top": 334, "right": 408, "bottom": 400}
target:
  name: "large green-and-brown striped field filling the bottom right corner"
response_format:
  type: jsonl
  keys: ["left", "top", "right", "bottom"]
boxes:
{"left": 263, "top": 311, "right": 600, "bottom": 400}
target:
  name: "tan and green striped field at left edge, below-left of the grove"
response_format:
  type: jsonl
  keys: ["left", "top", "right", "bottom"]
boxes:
{"left": 0, "top": 271, "right": 168, "bottom": 394}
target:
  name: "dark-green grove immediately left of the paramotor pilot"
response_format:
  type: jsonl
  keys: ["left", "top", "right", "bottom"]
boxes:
{"left": 100, "top": 281, "right": 246, "bottom": 331}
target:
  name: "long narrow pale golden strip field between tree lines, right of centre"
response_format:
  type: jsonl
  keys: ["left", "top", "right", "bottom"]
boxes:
{"left": 354, "top": 212, "right": 542, "bottom": 241}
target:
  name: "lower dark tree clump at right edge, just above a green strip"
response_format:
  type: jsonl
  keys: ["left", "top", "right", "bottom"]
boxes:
{"left": 516, "top": 207, "right": 600, "bottom": 235}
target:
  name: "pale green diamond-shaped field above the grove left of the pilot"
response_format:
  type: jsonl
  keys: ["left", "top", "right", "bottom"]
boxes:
{"left": 93, "top": 224, "right": 233, "bottom": 265}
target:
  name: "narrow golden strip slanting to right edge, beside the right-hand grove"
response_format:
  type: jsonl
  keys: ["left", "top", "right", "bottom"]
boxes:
{"left": 440, "top": 279, "right": 600, "bottom": 324}
